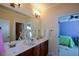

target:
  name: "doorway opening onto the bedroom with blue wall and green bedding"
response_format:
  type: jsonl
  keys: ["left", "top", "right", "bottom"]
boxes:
{"left": 58, "top": 14, "right": 79, "bottom": 56}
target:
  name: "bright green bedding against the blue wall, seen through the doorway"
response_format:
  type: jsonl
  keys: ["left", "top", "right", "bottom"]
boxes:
{"left": 59, "top": 36, "right": 74, "bottom": 47}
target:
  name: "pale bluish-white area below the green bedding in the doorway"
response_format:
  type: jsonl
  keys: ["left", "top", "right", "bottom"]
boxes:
{"left": 59, "top": 45, "right": 78, "bottom": 56}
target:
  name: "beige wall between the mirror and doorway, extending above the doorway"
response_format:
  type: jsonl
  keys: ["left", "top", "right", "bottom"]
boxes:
{"left": 41, "top": 4, "right": 79, "bottom": 55}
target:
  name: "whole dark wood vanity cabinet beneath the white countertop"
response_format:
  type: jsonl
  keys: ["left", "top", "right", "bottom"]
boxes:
{"left": 17, "top": 40, "right": 48, "bottom": 56}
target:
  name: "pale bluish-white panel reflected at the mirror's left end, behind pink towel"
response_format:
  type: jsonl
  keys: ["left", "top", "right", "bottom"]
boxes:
{"left": 0, "top": 19, "right": 10, "bottom": 42}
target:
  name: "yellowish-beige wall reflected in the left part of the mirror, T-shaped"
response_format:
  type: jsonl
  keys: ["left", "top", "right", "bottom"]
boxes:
{"left": 0, "top": 6, "right": 30, "bottom": 40}
